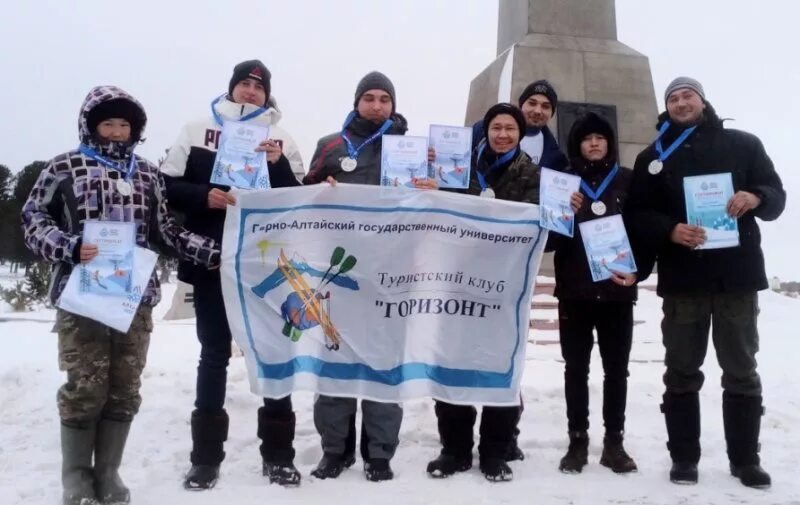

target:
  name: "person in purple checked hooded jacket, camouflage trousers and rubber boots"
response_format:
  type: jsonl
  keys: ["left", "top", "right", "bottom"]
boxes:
{"left": 21, "top": 86, "right": 220, "bottom": 505}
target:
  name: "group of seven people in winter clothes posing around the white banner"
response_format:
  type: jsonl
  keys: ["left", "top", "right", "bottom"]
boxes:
{"left": 22, "top": 56, "right": 785, "bottom": 504}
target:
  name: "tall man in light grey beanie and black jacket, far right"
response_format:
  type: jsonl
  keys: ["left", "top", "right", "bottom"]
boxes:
{"left": 625, "top": 77, "right": 786, "bottom": 488}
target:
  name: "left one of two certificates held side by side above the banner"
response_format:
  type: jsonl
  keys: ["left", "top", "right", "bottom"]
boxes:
{"left": 381, "top": 135, "right": 428, "bottom": 188}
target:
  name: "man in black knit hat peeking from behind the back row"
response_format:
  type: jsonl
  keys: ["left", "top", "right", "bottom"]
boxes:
{"left": 472, "top": 79, "right": 568, "bottom": 170}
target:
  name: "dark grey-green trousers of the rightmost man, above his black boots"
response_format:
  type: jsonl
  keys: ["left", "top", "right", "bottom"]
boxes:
{"left": 661, "top": 292, "right": 761, "bottom": 396}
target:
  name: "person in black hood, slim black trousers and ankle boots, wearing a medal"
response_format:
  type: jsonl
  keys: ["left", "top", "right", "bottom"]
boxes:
{"left": 547, "top": 112, "right": 637, "bottom": 473}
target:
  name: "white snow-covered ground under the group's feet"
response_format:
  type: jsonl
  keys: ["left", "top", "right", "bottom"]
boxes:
{"left": 0, "top": 279, "right": 800, "bottom": 505}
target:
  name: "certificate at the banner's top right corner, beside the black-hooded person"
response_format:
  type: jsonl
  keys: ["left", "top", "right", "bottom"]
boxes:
{"left": 539, "top": 167, "right": 581, "bottom": 237}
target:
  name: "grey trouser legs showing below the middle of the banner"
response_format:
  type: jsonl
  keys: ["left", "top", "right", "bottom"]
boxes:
{"left": 314, "top": 395, "right": 403, "bottom": 459}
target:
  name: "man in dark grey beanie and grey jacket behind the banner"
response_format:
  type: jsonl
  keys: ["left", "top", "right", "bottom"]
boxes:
{"left": 303, "top": 72, "right": 436, "bottom": 481}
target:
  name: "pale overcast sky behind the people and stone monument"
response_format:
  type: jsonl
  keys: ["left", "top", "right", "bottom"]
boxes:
{"left": 0, "top": 0, "right": 800, "bottom": 280}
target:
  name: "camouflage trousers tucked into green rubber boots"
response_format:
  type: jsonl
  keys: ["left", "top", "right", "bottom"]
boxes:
{"left": 54, "top": 305, "right": 153, "bottom": 427}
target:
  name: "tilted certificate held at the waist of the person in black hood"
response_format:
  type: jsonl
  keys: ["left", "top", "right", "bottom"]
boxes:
{"left": 578, "top": 214, "right": 636, "bottom": 282}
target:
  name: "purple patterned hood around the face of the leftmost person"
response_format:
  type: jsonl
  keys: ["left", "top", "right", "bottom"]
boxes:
{"left": 78, "top": 86, "right": 147, "bottom": 160}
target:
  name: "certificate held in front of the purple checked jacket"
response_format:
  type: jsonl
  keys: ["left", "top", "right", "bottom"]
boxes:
{"left": 80, "top": 221, "right": 136, "bottom": 296}
